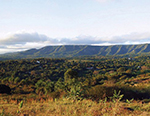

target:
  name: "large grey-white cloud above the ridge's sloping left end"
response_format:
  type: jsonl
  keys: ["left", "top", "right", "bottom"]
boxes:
{"left": 0, "top": 32, "right": 58, "bottom": 54}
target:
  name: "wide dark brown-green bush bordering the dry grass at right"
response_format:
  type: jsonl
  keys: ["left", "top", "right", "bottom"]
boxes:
{"left": 85, "top": 85, "right": 150, "bottom": 101}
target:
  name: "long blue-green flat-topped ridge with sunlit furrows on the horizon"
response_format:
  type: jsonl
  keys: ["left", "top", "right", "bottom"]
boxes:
{"left": 1, "top": 44, "right": 150, "bottom": 59}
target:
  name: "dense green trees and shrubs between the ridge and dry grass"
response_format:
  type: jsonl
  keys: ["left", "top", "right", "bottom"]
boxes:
{"left": 0, "top": 56, "right": 150, "bottom": 100}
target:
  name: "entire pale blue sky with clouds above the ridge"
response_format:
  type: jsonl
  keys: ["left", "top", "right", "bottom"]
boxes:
{"left": 0, "top": 0, "right": 150, "bottom": 54}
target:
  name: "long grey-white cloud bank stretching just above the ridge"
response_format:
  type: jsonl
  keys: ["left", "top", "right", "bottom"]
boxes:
{"left": 0, "top": 32, "right": 150, "bottom": 54}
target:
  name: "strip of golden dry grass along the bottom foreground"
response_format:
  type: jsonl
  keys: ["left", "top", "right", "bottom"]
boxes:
{"left": 0, "top": 98, "right": 150, "bottom": 116}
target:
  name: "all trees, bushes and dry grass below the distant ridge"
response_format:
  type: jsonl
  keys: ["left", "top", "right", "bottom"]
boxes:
{"left": 0, "top": 56, "right": 150, "bottom": 116}
